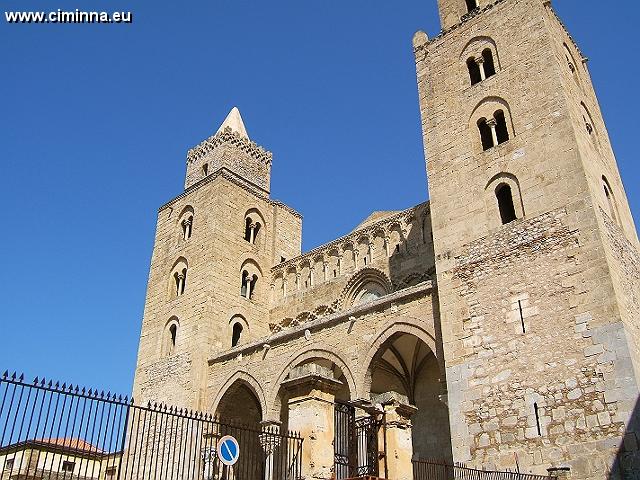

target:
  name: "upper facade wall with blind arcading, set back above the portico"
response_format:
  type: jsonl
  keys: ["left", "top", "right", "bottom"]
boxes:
{"left": 270, "top": 204, "right": 434, "bottom": 331}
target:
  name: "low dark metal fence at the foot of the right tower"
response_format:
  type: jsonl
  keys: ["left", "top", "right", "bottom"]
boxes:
{"left": 412, "top": 460, "right": 555, "bottom": 480}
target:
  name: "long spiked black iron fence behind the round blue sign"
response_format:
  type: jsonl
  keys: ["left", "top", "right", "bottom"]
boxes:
{"left": 0, "top": 373, "right": 302, "bottom": 480}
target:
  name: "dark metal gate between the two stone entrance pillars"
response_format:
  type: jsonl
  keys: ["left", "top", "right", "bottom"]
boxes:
{"left": 333, "top": 402, "right": 381, "bottom": 480}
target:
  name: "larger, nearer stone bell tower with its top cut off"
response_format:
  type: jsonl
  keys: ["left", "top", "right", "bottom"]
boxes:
{"left": 414, "top": 0, "right": 640, "bottom": 478}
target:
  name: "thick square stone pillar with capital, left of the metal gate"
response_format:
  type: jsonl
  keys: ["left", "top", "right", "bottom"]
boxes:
{"left": 283, "top": 363, "right": 342, "bottom": 480}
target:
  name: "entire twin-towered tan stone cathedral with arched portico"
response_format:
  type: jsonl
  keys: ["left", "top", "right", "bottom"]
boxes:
{"left": 134, "top": 0, "right": 640, "bottom": 479}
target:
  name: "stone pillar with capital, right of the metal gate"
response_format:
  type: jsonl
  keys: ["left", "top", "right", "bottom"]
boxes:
{"left": 372, "top": 392, "right": 418, "bottom": 480}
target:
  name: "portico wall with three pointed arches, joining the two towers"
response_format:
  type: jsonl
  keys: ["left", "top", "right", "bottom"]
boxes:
{"left": 207, "top": 282, "right": 442, "bottom": 421}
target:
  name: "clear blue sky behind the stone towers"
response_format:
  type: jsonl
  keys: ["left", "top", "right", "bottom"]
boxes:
{"left": 0, "top": 0, "right": 640, "bottom": 393}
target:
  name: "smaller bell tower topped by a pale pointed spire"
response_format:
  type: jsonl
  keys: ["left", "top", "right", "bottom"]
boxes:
{"left": 134, "top": 107, "right": 302, "bottom": 411}
